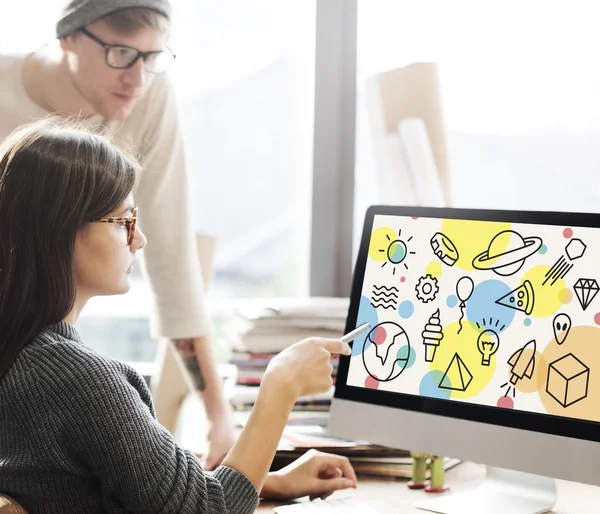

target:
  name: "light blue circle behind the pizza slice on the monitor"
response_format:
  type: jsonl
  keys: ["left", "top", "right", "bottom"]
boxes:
{"left": 463, "top": 280, "right": 517, "bottom": 334}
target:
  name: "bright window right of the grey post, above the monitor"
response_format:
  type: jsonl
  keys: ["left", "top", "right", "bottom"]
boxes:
{"left": 356, "top": 0, "right": 600, "bottom": 228}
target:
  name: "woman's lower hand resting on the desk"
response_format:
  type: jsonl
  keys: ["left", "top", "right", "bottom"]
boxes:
{"left": 261, "top": 450, "right": 356, "bottom": 500}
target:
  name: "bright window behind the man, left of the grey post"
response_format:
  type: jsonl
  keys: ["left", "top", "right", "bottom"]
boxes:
{"left": 0, "top": 0, "right": 316, "bottom": 361}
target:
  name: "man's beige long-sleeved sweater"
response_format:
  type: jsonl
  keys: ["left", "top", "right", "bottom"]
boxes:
{"left": 0, "top": 51, "right": 209, "bottom": 339}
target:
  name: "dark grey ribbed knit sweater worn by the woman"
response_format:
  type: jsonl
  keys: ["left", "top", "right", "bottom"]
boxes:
{"left": 0, "top": 322, "right": 258, "bottom": 514}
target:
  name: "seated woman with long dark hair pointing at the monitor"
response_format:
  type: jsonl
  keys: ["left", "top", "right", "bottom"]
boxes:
{"left": 0, "top": 119, "right": 356, "bottom": 514}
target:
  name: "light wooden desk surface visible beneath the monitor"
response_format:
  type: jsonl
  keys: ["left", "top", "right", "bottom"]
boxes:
{"left": 256, "top": 462, "right": 600, "bottom": 514}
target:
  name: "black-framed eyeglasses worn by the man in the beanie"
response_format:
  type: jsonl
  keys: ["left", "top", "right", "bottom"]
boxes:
{"left": 79, "top": 28, "right": 176, "bottom": 75}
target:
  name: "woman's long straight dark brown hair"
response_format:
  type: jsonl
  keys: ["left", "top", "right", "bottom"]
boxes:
{"left": 0, "top": 118, "right": 139, "bottom": 380}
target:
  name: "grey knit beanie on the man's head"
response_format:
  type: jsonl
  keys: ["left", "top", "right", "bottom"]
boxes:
{"left": 56, "top": 0, "right": 171, "bottom": 38}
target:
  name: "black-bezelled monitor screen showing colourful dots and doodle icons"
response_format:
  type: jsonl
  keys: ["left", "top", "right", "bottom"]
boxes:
{"left": 336, "top": 207, "right": 600, "bottom": 440}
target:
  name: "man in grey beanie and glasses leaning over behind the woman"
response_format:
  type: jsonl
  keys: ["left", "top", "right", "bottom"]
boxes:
{"left": 0, "top": 0, "right": 244, "bottom": 500}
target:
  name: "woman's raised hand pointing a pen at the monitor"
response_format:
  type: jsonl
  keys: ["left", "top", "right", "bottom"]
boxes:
{"left": 261, "top": 337, "right": 352, "bottom": 402}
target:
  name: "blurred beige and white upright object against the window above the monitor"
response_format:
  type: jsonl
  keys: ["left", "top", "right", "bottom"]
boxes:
{"left": 365, "top": 62, "right": 451, "bottom": 207}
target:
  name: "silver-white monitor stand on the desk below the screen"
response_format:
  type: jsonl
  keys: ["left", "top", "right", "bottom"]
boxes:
{"left": 415, "top": 466, "right": 556, "bottom": 514}
